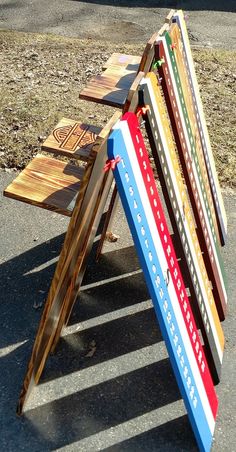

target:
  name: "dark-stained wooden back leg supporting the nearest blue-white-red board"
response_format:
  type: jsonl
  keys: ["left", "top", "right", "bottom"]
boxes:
{"left": 17, "top": 113, "right": 120, "bottom": 414}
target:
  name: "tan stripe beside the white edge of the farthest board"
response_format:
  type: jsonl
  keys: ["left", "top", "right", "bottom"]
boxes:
{"left": 168, "top": 23, "right": 220, "bottom": 242}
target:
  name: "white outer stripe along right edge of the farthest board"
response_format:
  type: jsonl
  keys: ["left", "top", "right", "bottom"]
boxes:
{"left": 173, "top": 11, "right": 227, "bottom": 244}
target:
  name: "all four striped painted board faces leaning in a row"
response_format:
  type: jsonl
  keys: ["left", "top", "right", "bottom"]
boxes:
{"left": 105, "top": 11, "right": 227, "bottom": 451}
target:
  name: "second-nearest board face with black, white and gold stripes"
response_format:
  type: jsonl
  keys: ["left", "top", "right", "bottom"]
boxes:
{"left": 140, "top": 73, "right": 224, "bottom": 383}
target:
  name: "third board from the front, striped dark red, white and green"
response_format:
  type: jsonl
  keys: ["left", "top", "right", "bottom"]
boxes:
{"left": 156, "top": 33, "right": 227, "bottom": 320}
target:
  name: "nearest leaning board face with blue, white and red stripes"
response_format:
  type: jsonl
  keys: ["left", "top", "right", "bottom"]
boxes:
{"left": 108, "top": 113, "right": 218, "bottom": 451}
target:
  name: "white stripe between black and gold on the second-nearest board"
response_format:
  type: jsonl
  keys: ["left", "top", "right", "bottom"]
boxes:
{"left": 142, "top": 78, "right": 223, "bottom": 362}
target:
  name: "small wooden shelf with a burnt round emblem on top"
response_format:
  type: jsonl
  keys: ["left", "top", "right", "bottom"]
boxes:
{"left": 42, "top": 118, "right": 101, "bottom": 161}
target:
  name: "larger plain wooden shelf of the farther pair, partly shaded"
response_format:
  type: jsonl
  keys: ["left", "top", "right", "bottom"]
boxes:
{"left": 79, "top": 66, "right": 136, "bottom": 108}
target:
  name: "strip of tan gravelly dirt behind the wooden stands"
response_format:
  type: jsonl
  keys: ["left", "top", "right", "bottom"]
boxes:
{"left": 0, "top": 31, "right": 236, "bottom": 188}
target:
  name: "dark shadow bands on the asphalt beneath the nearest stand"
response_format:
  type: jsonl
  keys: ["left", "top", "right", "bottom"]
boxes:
{"left": 0, "top": 235, "right": 197, "bottom": 452}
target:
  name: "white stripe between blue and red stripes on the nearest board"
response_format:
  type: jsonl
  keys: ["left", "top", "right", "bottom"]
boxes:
{"left": 119, "top": 121, "right": 215, "bottom": 434}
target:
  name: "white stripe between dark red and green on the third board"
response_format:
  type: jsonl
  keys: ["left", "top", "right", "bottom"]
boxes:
{"left": 157, "top": 37, "right": 227, "bottom": 303}
